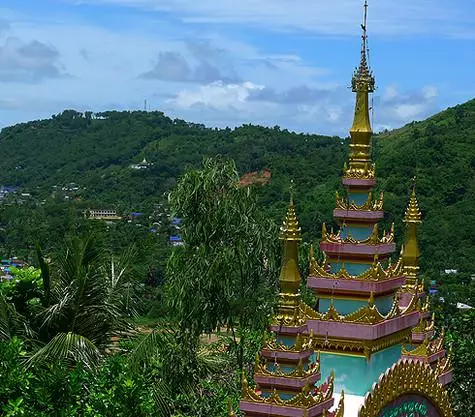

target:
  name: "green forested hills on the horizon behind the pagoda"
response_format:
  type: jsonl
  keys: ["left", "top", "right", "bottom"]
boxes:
{"left": 0, "top": 100, "right": 475, "bottom": 272}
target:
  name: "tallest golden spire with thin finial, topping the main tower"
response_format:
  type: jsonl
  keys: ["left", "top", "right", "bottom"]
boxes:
{"left": 345, "top": 0, "right": 375, "bottom": 178}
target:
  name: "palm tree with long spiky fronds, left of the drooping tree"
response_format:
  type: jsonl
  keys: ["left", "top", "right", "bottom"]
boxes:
{"left": 28, "top": 236, "right": 134, "bottom": 368}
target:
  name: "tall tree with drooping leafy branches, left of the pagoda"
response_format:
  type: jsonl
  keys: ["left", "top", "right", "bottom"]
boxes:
{"left": 168, "top": 158, "right": 278, "bottom": 369}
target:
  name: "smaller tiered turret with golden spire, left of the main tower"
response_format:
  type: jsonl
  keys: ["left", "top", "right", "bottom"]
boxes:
{"left": 240, "top": 195, "right": 343, "bottom": 417}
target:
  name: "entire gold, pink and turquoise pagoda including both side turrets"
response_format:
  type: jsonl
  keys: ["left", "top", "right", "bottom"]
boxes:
{"left": 238, "top": 1, "right": 452, "bottom": 417}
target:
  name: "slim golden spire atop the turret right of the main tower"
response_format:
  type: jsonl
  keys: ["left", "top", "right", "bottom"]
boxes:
{"left": 402, "top": 178, "right": 422, "bottom": 286}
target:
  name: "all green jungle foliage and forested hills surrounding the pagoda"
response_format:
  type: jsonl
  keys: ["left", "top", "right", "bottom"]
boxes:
{"left": 0, "top": 100, "right": 475, "bottom": 417}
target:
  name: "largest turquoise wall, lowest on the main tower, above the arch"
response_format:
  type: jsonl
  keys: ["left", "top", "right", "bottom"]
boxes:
{"left": 313, "top": 345, "right": 401, "bottom": 396}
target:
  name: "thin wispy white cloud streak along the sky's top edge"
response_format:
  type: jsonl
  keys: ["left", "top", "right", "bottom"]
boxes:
{"left": 66, "top": 0, "right": 475, "bottom": 36}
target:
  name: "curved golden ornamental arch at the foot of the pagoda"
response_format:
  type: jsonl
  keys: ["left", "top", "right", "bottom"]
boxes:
{"left": 358, "top": 360, "right": 453, "bottom": 417}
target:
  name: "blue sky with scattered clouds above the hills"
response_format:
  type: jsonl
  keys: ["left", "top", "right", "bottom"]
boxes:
{"left": 0, "top": 0, "right": 475, "bottom": 136}
